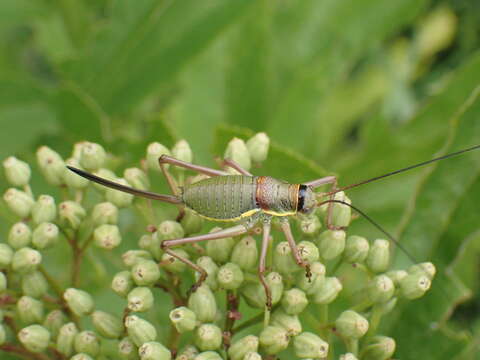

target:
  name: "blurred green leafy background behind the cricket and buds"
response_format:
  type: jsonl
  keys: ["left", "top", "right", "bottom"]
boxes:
{"left": 0, "top": 0, "right": 480, "bottom": 359}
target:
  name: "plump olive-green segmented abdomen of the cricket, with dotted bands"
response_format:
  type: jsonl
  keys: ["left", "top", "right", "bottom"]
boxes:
{"left": 182, "top": 175, "right": 258, "bottom": 220}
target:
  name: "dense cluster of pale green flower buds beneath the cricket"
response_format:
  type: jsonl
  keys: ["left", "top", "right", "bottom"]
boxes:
{"left": 0, "top": 133, "right": 435, "bottom": 360}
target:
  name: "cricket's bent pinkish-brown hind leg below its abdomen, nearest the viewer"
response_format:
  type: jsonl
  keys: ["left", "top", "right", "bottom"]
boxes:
{"left": 160, "top": 225, "right": 251, "bottom": 292}
